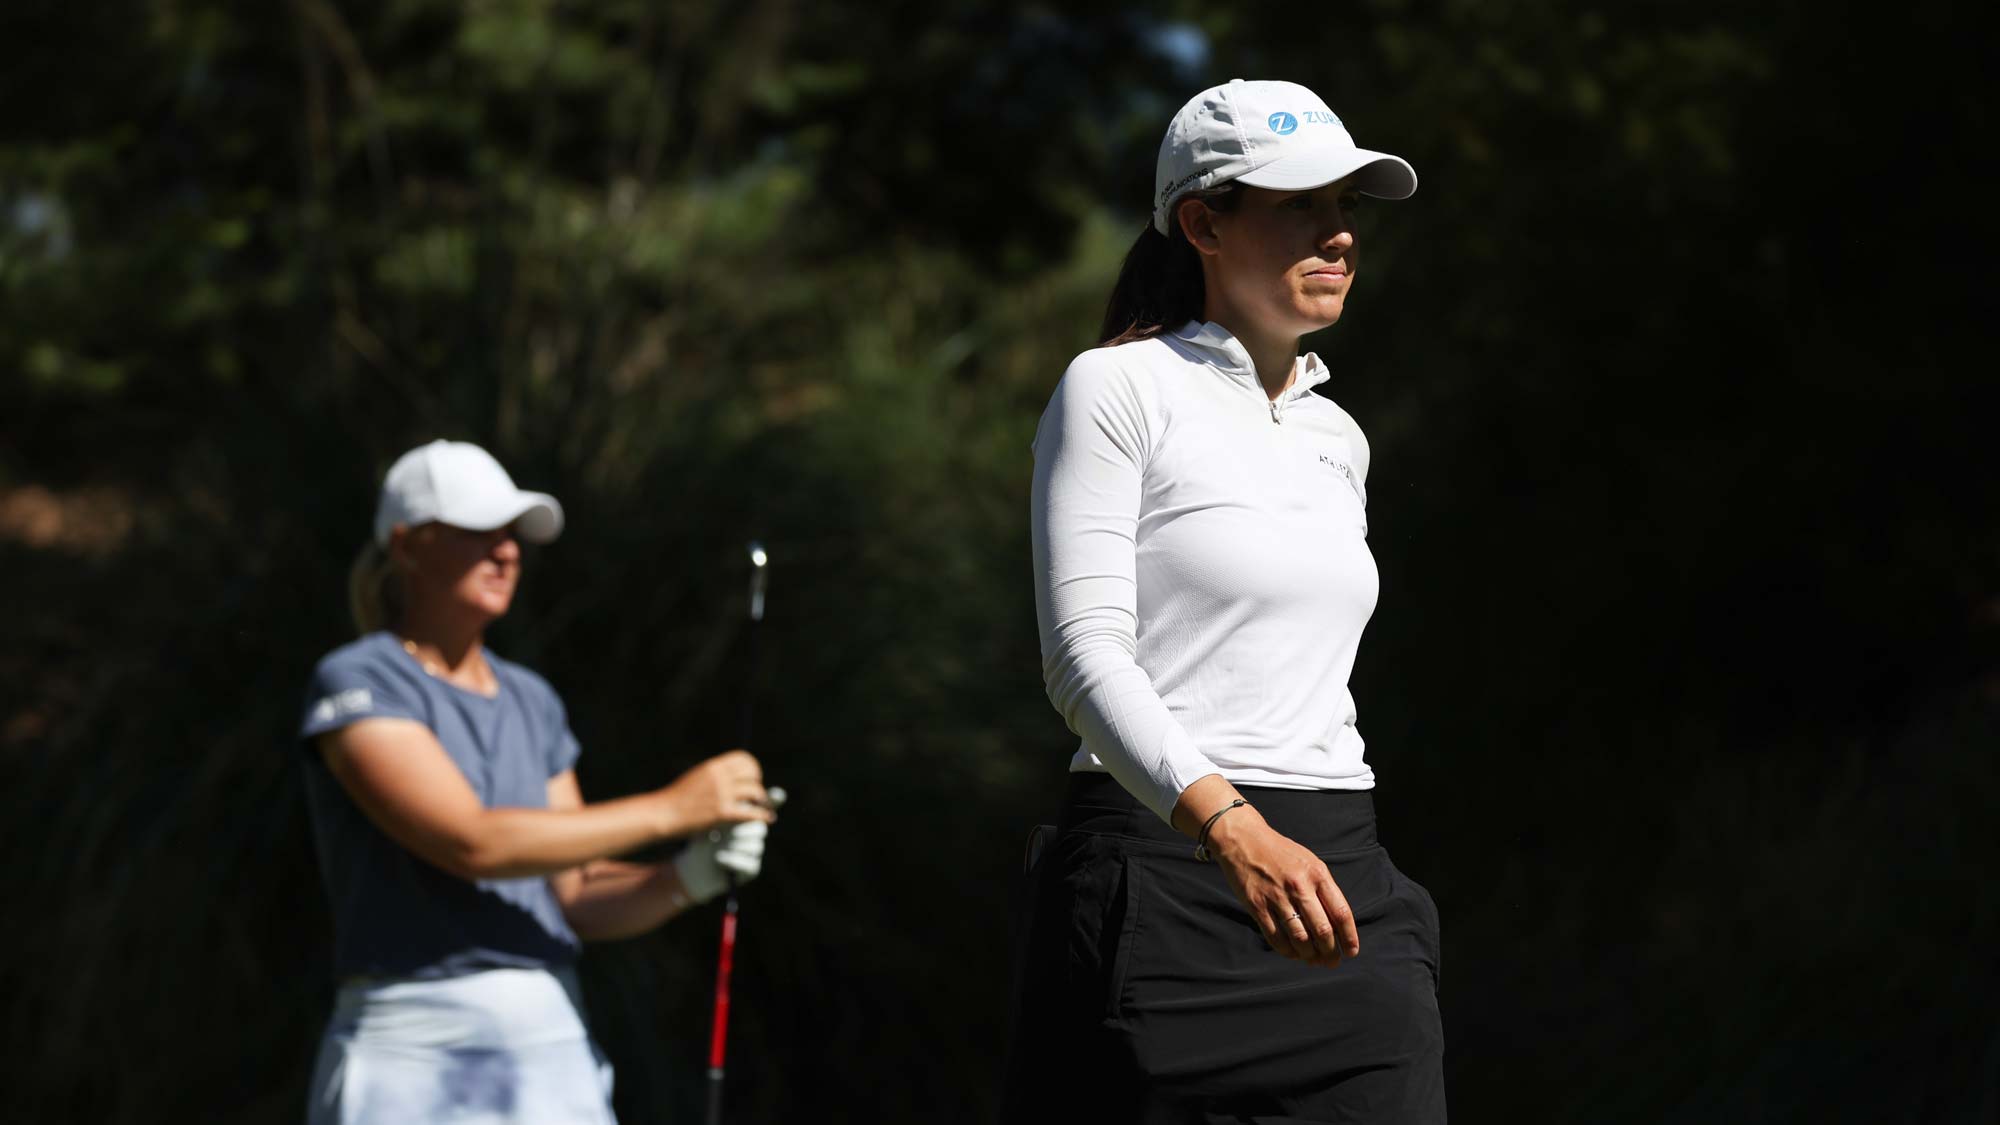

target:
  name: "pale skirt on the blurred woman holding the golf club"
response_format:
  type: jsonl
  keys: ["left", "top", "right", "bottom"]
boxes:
{"left": 306, "top": 969, "right": 614, "bottom": 1125}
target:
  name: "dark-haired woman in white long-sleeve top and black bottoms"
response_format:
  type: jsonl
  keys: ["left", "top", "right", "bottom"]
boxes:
{"left": 1006, "top": 80, "right": 1444, "bottom": 1125}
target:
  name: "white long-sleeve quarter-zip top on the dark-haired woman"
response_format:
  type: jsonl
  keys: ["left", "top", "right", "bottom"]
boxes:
{"left": 1032, "top": 322, "right": 1378, "bottom": 821}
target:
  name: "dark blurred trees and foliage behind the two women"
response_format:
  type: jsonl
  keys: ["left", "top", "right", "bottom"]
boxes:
{"left": 0, "top": 0, "right": 2000, "bottom": 1123}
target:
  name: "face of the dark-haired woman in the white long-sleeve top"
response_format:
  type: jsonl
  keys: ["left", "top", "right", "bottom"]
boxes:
{"left": 1192, "top": 180, "right": 1360, "bottom": 336}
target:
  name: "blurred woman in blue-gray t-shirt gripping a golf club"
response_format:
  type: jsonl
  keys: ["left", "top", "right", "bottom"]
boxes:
{"left": 300, "top": 440, "right": 774, "bottom": 1125}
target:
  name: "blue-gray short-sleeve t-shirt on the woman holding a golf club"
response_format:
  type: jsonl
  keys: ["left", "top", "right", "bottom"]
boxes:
{"left": 298, "top": 633, "right": 580, "bottom": 979}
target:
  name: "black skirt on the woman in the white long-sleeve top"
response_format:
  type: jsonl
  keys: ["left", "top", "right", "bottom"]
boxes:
{"left": 1002, "top": 773, "right": 1444, "bottom": 1125}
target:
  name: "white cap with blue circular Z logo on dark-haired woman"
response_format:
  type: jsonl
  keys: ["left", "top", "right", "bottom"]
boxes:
{"left": 1152, "top": 78, "right": 1416, "bottom": 234}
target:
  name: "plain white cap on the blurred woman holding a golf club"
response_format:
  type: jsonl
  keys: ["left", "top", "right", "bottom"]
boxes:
{"left": 376, "top": 440, "right": 562, "bottom": 546}
